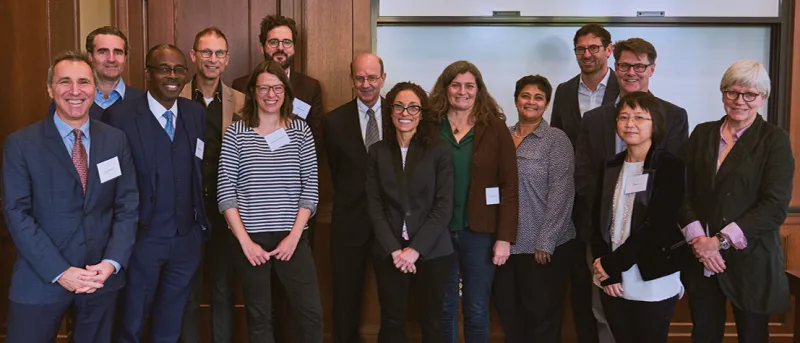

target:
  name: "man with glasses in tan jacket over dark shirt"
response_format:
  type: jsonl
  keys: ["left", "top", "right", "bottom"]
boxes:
{"left": 181, "top": 27, "right": 244, "bottom": 343}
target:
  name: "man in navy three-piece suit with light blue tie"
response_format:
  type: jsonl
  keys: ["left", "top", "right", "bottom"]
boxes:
{"left": 103, "top": 44, "right": 208, "bottom": 343}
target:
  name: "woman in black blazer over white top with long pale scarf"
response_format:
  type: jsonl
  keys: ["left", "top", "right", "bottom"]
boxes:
{"left": 592, "top": 92, "right": 691, "bottom": 343}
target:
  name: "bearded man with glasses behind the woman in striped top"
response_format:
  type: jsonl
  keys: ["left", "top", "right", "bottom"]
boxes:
{"left": 232, "top": 15, "right": 324, "bottom": 152}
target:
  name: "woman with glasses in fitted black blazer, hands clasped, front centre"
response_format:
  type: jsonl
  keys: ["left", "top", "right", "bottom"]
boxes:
{"left": 366, "top": 82, "right": 453, "bottom": 342}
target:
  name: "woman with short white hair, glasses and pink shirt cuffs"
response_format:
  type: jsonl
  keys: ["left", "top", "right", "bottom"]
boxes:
{"left": 681, "top": 60, "right": 794, "bottom": 343}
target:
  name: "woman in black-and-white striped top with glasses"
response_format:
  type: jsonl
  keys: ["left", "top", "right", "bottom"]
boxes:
{"left": 217, "top": 60, "right": 322, "bottom": 342}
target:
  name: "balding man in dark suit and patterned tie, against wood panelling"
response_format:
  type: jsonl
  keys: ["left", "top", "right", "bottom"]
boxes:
{"left": 325, "top": 54, "right": 386, "bottom": 343}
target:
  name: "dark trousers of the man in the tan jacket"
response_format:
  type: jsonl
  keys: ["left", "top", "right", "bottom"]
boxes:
{"left": 180, "top": 223, "right": 237, "bottom": 343}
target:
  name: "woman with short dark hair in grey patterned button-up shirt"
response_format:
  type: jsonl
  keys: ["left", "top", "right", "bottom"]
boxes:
{"left": 494, "top": 75, "right": 577, "bottom": 343}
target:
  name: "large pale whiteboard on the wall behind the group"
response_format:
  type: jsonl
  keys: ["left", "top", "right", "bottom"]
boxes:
{"left": 377, "top": 25, "right": 770, "bottom": 129}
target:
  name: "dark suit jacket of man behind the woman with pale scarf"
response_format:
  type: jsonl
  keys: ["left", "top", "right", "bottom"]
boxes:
{"left": 572, "top": 98, "right": 689, "bottom": 243}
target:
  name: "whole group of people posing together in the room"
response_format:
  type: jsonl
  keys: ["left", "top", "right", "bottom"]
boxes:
{"left": 2, "top": 16, "right": 794, "bottom": 343}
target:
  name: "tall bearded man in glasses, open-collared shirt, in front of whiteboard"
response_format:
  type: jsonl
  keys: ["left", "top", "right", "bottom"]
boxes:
{"left": 552, "top": 24, "right": 619, "bottom": 343}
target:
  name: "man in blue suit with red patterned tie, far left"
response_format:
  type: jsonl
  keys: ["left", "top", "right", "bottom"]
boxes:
{"left": 3, "top": 52, "right": 139, "bottom": 343}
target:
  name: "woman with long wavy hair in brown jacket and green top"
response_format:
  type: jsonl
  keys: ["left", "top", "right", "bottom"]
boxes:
{"left": 430, "top": 61, "right": 519, "bottom": 343}
